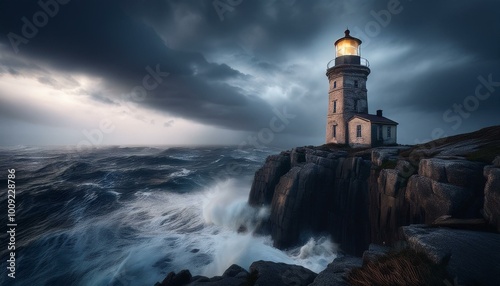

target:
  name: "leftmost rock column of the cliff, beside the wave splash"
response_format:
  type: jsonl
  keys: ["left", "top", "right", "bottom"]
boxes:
{"left": 248, "top": 152, "right": 290, "bottom": 206}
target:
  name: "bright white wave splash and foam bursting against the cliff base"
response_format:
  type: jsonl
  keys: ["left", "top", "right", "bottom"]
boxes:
{"left": 199, "top": 180, "right": 336, "bottom": 276}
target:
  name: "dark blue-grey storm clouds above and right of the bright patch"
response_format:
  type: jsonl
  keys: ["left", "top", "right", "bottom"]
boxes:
{"left": 0, "top": 0, "right": 500, "bottom": 144}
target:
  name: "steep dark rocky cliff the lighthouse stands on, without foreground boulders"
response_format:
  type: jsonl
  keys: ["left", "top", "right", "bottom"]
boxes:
{"left": 249, "top": 126, "right": 500, "bottom": 255}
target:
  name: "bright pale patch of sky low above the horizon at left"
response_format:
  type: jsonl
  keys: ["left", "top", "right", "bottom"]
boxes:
{"left": 0, "top": 68, "right": 249, "bottom": 145}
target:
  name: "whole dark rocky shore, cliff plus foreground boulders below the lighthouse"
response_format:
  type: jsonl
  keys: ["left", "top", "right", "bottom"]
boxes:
{"left": 157, "top": 126, "right": 500, "bottom": 286}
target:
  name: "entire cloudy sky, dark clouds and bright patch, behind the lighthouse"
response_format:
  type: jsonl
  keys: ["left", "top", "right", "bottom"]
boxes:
{"left": 0, "top": 0, "right": 500, "bottom": 147}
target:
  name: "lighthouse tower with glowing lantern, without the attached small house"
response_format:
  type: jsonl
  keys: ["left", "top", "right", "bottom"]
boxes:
{"left": 326, "top": 30, "right": 370, "bottom": 144}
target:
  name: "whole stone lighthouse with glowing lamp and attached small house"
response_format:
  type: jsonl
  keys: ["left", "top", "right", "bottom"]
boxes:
{"left": 326, "top": 30, "right": 398, "bottom": 147}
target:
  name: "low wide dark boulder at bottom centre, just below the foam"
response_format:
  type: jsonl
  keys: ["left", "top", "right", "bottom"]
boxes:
{"left": 250, "top": 260, "right": 317, "bottom": 286}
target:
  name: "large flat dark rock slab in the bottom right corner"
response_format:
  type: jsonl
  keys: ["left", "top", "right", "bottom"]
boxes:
{"left": 402, "top": 225, "right": 500, "bottom": 285}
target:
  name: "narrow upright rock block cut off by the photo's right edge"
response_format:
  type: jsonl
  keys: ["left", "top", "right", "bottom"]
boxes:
{"left": 483, "top": 164, "right": 500, "bottom": 232}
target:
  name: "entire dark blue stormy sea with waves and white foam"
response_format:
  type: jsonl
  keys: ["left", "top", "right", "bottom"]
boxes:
{"left": 0, "top": 146, "right": 335, "bottom": 286}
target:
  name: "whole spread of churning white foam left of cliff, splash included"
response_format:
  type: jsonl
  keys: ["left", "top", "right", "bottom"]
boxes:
{"left": 21, "top": 180, "right": 335, "bottom": 285}
